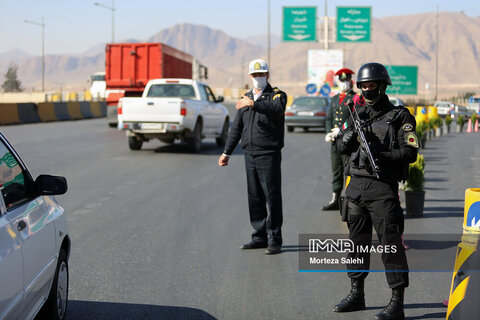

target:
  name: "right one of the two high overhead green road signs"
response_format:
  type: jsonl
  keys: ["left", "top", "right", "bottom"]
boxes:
{"left": 337, "top": 7, "right": 372, "bottom": 42}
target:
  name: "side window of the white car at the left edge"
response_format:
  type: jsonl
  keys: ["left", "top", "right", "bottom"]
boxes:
{"left": 0, "top": 143, "right": 28, "bottom": 211}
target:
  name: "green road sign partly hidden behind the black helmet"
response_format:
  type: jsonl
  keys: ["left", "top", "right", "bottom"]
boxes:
{"left": 385, "top": 66, "right": 418, "bottom": 94}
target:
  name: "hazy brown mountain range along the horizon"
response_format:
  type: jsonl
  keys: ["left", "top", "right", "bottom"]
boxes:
{"left": 0, "top": 12, "right": 480, "bottom": 97}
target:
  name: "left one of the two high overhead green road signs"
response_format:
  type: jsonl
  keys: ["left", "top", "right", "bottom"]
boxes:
{"left": 283, "top": 7, "right": 317, "bottom": 41}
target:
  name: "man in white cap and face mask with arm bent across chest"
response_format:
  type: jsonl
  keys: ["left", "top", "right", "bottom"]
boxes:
{"left": 218, "top": 59, "right": 287, "bottom": 255}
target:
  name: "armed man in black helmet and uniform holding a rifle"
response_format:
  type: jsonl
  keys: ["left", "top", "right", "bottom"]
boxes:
{"left": 333, "top": 62, "right": 418, "bottom": 320}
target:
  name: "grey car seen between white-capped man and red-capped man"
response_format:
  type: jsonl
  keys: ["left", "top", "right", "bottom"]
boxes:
{"left": 285, "top": 96, "right": 330, "bottom": 132}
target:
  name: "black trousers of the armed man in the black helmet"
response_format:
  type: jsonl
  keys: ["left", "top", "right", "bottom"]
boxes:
{"left": 347, "top": 198, "right": 408, "bottom": 289}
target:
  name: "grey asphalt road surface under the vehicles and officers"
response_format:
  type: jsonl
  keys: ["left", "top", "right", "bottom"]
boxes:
{"left": 0, "top": 114, "right": 480, "bottom": 320}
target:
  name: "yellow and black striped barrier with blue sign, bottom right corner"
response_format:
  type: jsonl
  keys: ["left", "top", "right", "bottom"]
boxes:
{"left": 447, "top": 188, "right": 480, "bottom": 320}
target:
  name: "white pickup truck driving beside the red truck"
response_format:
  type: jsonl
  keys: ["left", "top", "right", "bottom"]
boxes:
{"left": 118, "top": 79, "right": 230, "bottom": 152}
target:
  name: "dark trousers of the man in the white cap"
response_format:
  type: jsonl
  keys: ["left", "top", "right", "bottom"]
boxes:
{"left": 245, "top": 152, "right": 283, "bottom": 245}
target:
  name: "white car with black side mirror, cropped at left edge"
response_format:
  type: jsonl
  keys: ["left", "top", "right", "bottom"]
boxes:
{"left": 0, "top": 133, "right": 70, "bottom": 320}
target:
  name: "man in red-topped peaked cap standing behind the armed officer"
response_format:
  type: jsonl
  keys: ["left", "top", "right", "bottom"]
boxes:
{"left": 322, "top": 68, "right": 355, "bottom": 210}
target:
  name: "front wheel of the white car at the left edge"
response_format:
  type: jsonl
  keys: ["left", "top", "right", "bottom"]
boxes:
{"left": 39, "top": 249, "right": 68, "bottom": 320}
